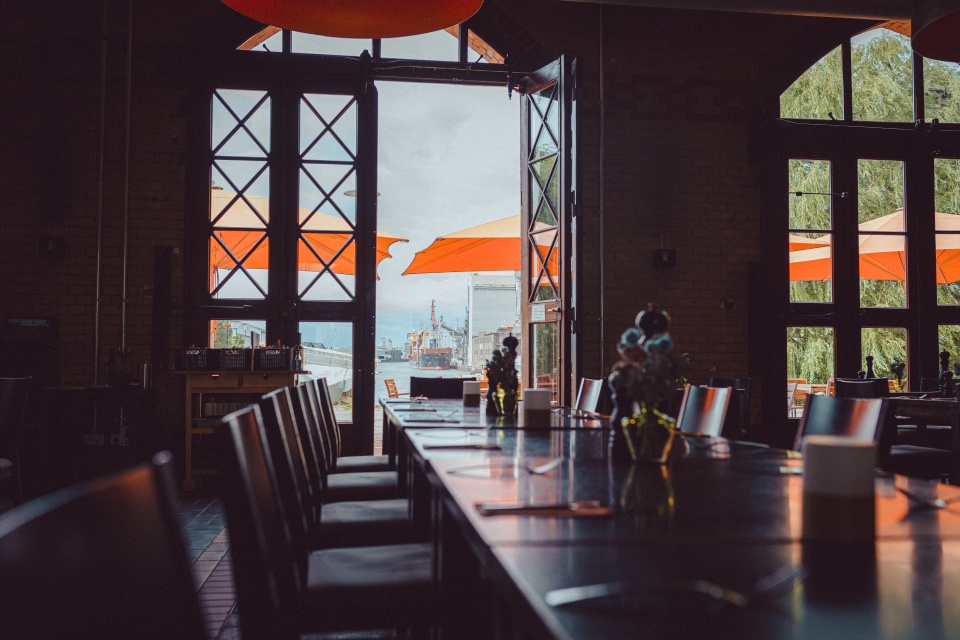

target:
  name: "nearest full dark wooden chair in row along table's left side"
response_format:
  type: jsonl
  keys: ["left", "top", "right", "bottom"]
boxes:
{"left": 222, "top": 405, "right": 437, "bottom": 640}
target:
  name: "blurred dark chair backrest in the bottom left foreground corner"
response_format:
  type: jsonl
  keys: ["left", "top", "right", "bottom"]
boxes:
{"left": 0, "top": 452, "right": 206, "bottom": 640}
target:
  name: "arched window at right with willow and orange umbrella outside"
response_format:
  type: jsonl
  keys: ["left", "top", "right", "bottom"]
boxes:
{"left": 776, "top": 25, "right": 960, "bottom": 416}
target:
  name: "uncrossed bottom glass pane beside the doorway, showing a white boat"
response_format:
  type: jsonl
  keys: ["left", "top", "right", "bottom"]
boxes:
{"left": 300, "top": 322, "right": 354, "bottom": 424}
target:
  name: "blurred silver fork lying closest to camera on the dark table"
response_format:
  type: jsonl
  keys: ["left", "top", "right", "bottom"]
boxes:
{"left": 544, "top": 564, "right": 807, "bottom": 609}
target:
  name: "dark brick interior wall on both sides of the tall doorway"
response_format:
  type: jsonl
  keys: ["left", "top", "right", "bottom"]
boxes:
{"left": 0, "top": 0, "right": 880, "bottom": 456}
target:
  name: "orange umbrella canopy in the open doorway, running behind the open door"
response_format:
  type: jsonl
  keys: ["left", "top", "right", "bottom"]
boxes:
{"left": 402, "top": 215, "right": 557, "bottom": 276}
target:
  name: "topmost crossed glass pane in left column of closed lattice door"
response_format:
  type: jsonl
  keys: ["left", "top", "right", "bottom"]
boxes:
{"left": 210, "top": 89, "right": 270, "bottom": 158}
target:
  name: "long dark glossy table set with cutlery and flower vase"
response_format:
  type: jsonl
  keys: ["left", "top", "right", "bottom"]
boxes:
{"left": 390, "top": 400, "right": 960, "bottom": 640}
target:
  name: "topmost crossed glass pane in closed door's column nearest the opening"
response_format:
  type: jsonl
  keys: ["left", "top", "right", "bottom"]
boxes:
{"left": 300, "top": 94, "right": 357, "bottom": 162}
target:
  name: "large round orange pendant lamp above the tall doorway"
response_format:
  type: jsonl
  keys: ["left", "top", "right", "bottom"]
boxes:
{"left": 222, "top": 0, "right": 483, "bottom": 39}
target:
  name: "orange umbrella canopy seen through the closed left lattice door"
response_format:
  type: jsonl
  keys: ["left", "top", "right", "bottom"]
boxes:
{"left": 209, "top": 189, "right": 407, "bottom": 282}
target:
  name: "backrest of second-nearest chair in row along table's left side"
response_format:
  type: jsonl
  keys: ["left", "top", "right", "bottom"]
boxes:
{"left": 259, "top": 387, "right": 319, "bottom": 552}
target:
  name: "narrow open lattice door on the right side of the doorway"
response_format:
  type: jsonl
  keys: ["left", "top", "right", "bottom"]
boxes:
{"left": 520, "top": 57, "right": 575, "bottom": 403}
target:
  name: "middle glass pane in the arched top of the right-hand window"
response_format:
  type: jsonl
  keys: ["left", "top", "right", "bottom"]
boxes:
{"left": 850, "top": 29, "right": 913, "bottom": 122}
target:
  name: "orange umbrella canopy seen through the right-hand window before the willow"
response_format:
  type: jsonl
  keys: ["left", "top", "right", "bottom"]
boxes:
{"left": 790, "top": 209, "right": 960, "bottom": 284}
